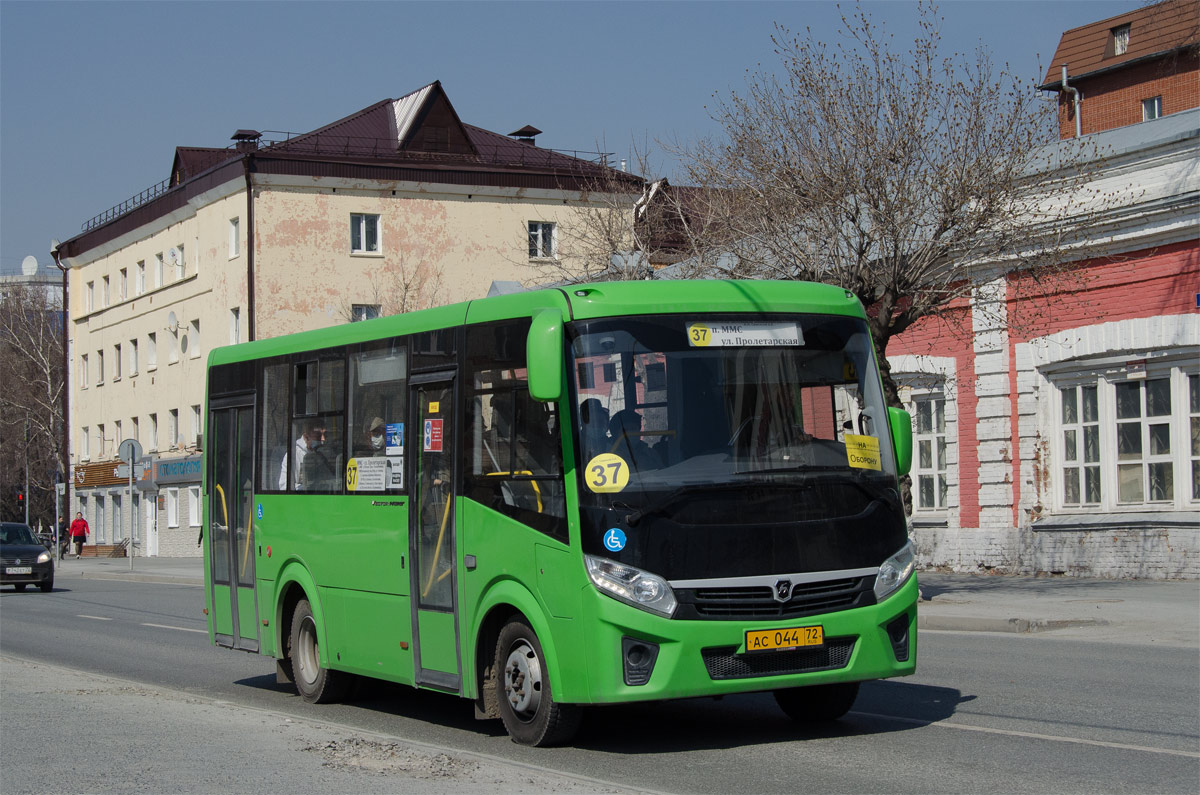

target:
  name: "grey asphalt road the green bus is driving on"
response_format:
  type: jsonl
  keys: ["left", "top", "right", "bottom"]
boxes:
{"left": 0, "top": 578, "right": 1200, "bottom": 793}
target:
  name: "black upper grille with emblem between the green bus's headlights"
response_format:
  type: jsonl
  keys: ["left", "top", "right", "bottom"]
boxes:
{"left": 674, "top": 576, "right": 875, "bottom": 621}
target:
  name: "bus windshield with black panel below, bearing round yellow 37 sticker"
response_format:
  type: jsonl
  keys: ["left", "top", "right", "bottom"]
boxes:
{"left": 570, "top": 315, "right": 905, "bottom": 578}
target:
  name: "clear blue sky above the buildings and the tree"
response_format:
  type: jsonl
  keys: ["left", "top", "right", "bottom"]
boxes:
{"left": 0, "top": 0, "right": 1144, "bottom": 275}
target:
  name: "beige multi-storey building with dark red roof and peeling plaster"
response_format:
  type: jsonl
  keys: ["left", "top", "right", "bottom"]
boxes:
{"left": 56, "top": 83, "right": 642, "bottom": 556}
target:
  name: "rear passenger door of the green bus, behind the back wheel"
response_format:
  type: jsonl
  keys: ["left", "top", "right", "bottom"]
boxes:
{"left": 208, "top": 405, "right": 258, "bottom": 651}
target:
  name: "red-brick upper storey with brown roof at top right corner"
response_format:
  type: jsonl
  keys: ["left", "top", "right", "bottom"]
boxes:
{"left": 1039, "top": 0, "right": 1200, "bottom": 138}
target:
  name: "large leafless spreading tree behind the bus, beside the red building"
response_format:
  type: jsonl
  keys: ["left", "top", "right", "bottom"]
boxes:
{"left": 685, "top": 2, "right": 1103, "bottom": 405}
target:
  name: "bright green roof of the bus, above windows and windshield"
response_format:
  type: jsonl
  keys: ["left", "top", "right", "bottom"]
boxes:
{"left": 209, "top": 280, "right": 866, "bottom": 366}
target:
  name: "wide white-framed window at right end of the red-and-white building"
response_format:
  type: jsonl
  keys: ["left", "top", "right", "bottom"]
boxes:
{"left": 1055, "top": 361, "right": 1200, "bottom": 512}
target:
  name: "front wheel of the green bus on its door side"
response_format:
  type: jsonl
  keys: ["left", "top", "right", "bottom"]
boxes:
{"left": 494, "top": 616, "right": 583, "bottom": 747}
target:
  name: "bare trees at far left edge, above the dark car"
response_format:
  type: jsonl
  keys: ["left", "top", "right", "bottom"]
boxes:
{"left": 0, "top": 283, "right": 66, "bottom": 525}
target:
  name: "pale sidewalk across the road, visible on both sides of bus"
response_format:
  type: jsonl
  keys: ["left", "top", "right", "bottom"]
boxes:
{"left": 56, "top": 557, "right": 1200, "bottom": 648}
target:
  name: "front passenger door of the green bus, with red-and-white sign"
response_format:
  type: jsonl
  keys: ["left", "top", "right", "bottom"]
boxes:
{"left": 407, "top": 372, "right": 462, "bottom": 692}
